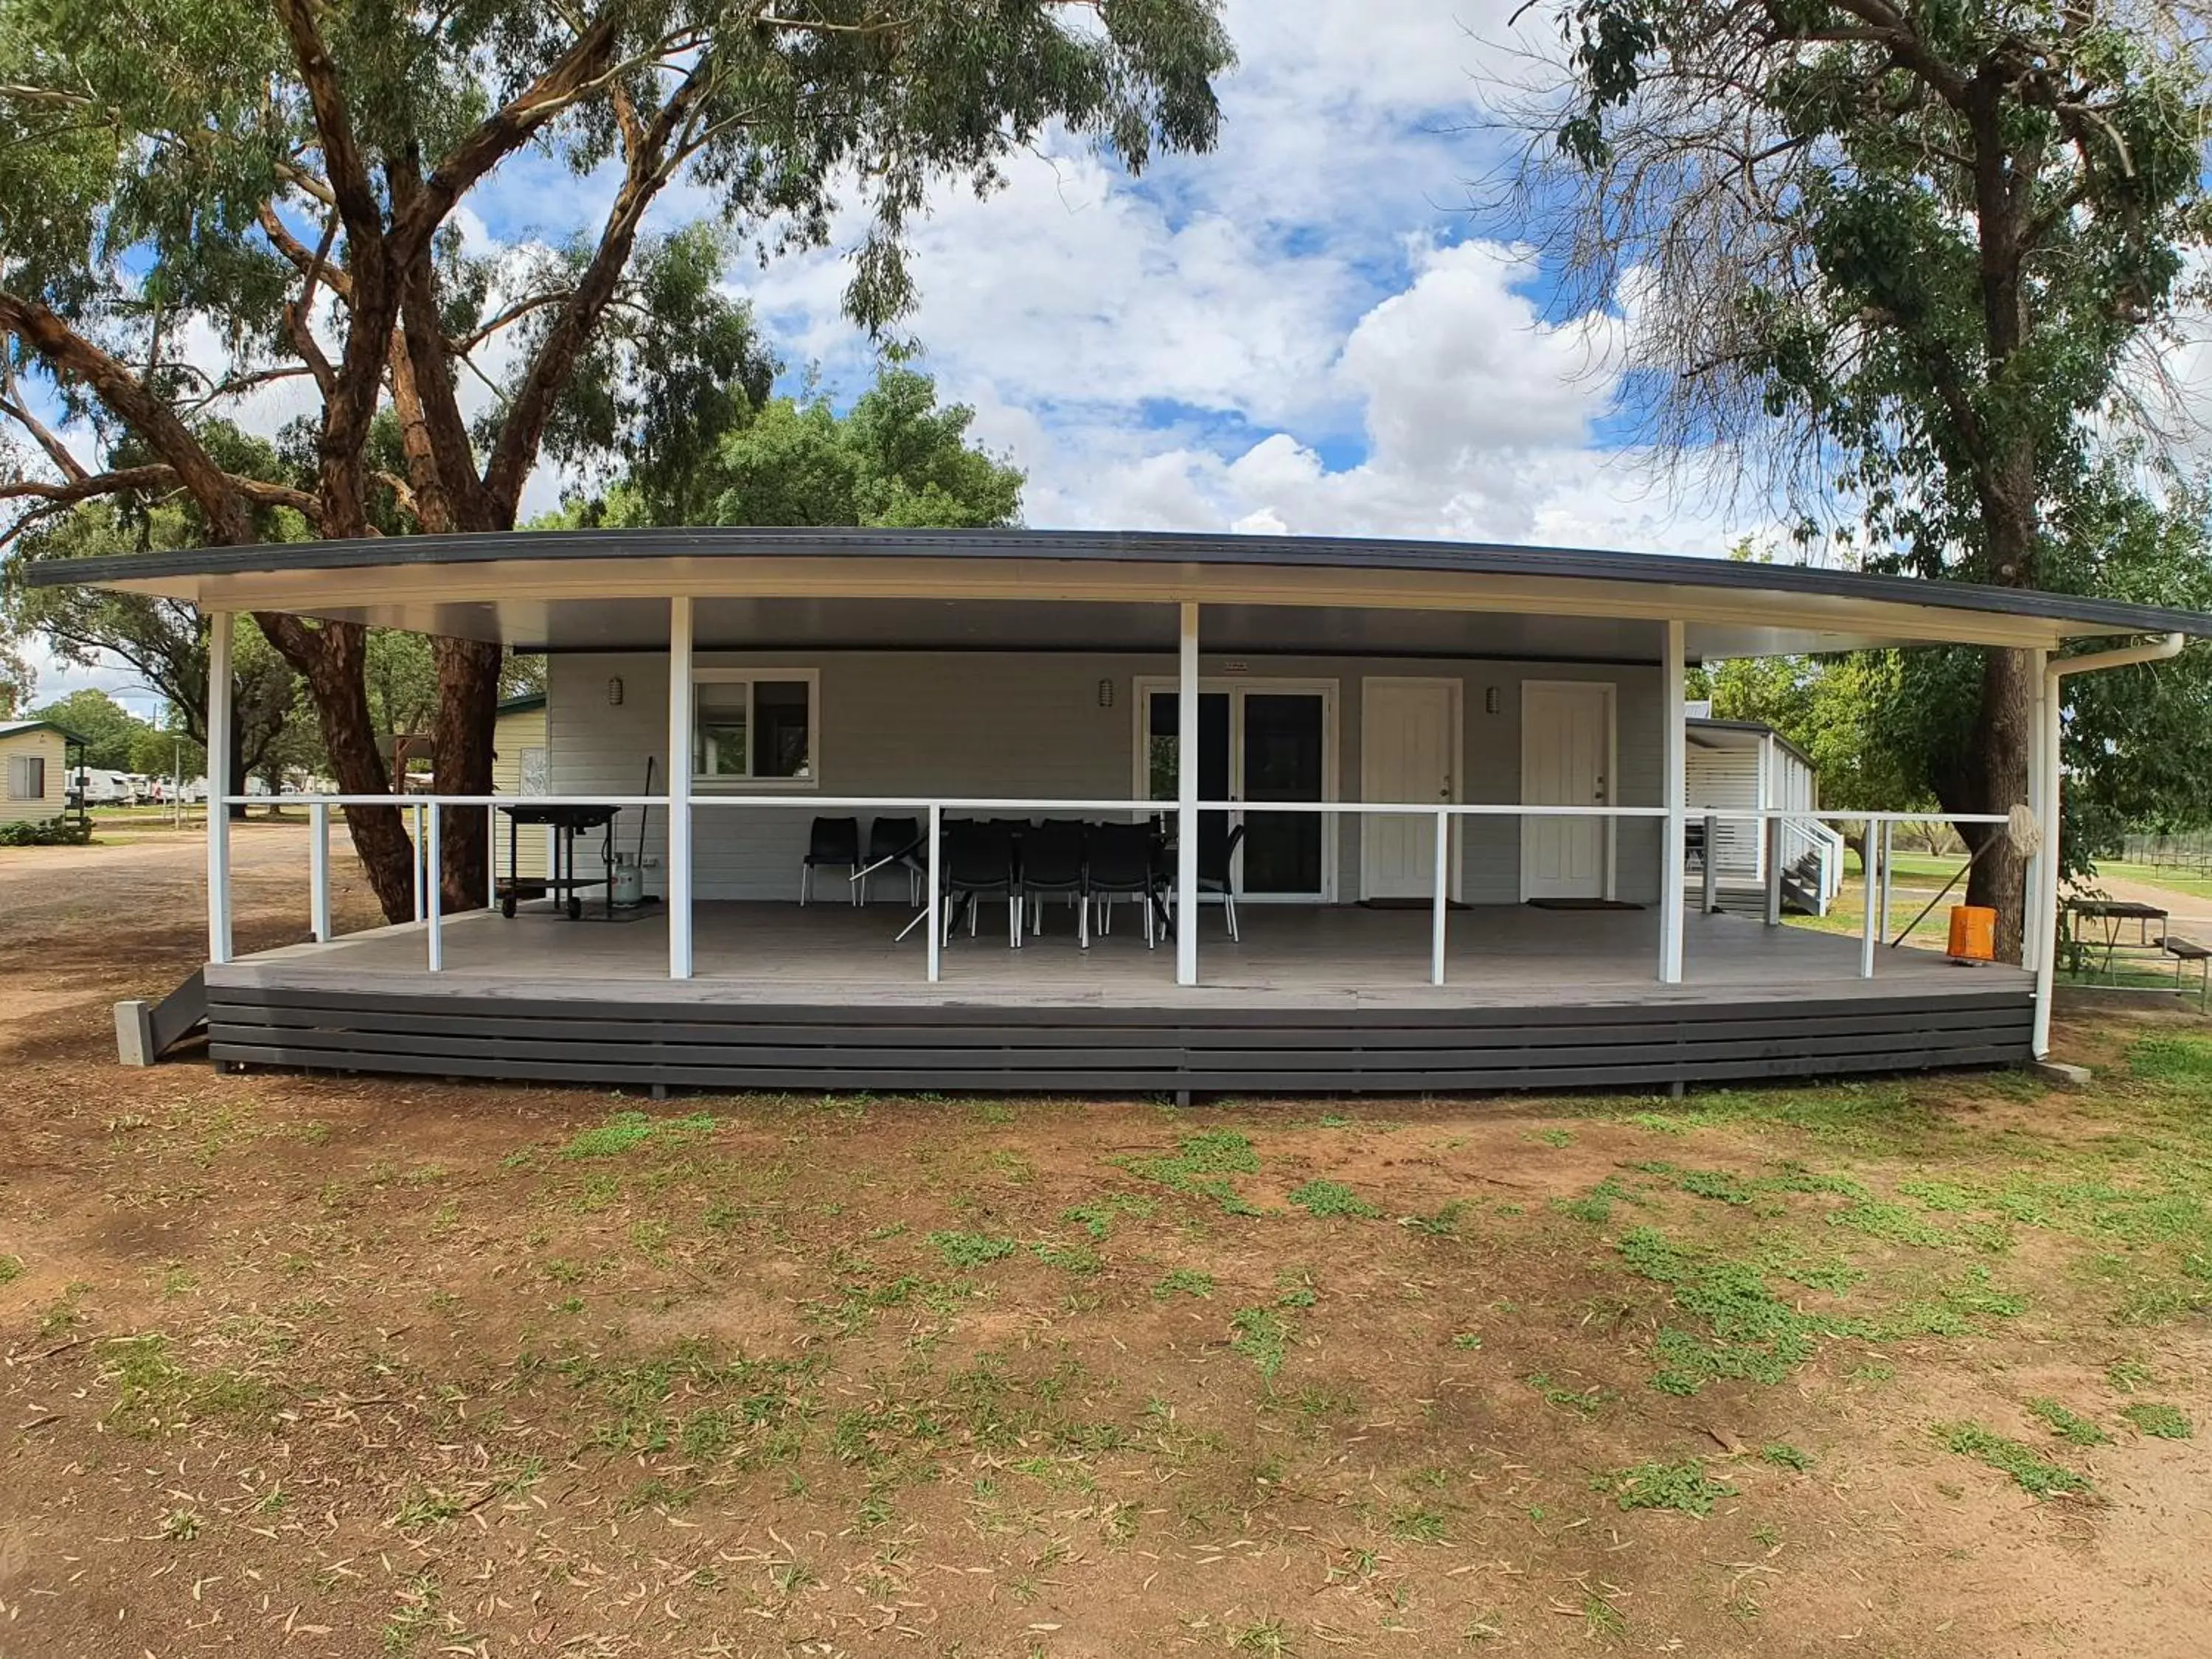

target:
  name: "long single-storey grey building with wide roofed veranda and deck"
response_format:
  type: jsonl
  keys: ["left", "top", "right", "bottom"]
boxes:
{"left": 31, "top": 529, "right": 2212, "bottom": 1095}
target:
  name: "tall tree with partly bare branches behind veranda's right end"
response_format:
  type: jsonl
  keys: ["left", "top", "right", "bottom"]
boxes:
{"left": 1509, "top": 0, "right": 2208, "bottom": 949}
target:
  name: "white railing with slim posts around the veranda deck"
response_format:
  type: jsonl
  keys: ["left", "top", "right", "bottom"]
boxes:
{"left": 219, "top": 792, "right": 2008, "bottom": 984}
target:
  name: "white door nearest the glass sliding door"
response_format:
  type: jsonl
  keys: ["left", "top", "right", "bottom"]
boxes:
{"left": 1360, "top": 679, "right": 1460, "bottom": 898}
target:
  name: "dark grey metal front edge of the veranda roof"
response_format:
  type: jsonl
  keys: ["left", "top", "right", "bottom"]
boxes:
{"left": 29, "top": 526, "right": 2212, "bottom": 637}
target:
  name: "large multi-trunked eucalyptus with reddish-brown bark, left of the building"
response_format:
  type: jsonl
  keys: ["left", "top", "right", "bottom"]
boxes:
{"left": 0, "top": 0, "right": 1230, "bottom": 916}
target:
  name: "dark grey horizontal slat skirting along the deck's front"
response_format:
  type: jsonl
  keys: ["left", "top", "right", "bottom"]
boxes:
{"left": 208, "top": 984, "right": 2033, "bottom": 1095}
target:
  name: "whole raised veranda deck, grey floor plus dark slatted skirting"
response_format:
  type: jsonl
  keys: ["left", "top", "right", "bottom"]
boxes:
{"left": 208, "top": 905, "right": 2033, "bottom": 1095}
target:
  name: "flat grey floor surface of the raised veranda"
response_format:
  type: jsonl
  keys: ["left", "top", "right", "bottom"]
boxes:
{"left": 208, "top": 902, "right": 2031, "bottom": 1009}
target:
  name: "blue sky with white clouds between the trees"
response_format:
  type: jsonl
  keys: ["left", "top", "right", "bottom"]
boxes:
{"left": 21, "top": 0, "right": 1730, "bottom": 697}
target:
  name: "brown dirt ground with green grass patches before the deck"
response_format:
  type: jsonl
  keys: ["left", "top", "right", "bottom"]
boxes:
{"left": 0, "top": 845, "right": 2212, "bottom": 1659}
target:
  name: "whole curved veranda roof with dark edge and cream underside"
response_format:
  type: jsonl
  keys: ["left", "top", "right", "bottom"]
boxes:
{"left": 29, "top": 529, "right": 2212, "bottom": 661}
